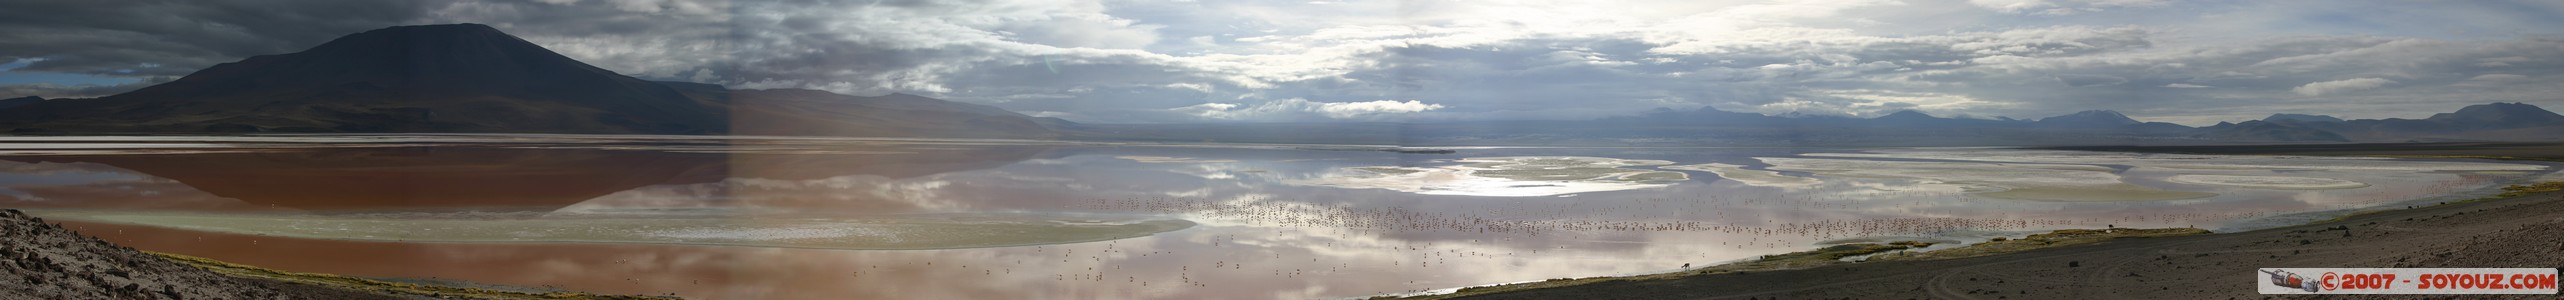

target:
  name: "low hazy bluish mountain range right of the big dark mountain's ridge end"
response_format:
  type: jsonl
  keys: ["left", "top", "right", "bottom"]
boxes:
{"left": 1072, "top": 103, "right": 2564, "bottom": 146}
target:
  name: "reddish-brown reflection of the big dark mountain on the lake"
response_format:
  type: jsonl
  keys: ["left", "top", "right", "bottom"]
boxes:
{"left": 0, "top": 146, "right": 1046, "bottom": 210}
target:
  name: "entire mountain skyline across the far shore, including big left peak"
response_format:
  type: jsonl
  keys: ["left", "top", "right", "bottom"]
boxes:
{"left": 0, "top": 23, "right": 2564, "bottom": 146}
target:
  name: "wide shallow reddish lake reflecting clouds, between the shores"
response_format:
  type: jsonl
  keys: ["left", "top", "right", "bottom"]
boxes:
{"left": 0, "top": 138, "right": 2551, "bottom": 300}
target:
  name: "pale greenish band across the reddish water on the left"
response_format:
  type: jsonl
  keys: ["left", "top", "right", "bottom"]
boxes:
{"left": 28, "top": 210, "right": 1192, "bottom": 249}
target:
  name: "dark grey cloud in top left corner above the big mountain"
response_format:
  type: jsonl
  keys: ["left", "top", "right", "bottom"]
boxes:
{"left": 0, "top": 0, "right": 423, "bottom": 77}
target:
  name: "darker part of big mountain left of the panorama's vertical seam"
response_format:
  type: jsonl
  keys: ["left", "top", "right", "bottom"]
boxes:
{"left": 0, "top": 23, "right": 728, "bottom": 133}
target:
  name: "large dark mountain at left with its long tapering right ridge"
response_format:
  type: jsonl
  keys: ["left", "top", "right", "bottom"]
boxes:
{"left": 0, "top": 23, "right": 1056, "bottom": 138}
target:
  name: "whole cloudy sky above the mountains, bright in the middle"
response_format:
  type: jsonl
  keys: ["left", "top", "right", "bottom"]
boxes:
{"left": 0, "top": 0, "right": 2564, "bottom": 126}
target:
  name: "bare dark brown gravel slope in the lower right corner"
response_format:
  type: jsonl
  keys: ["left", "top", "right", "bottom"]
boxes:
{"left": 1472, "top": 192, "right": 2564, "bottom": 300}
